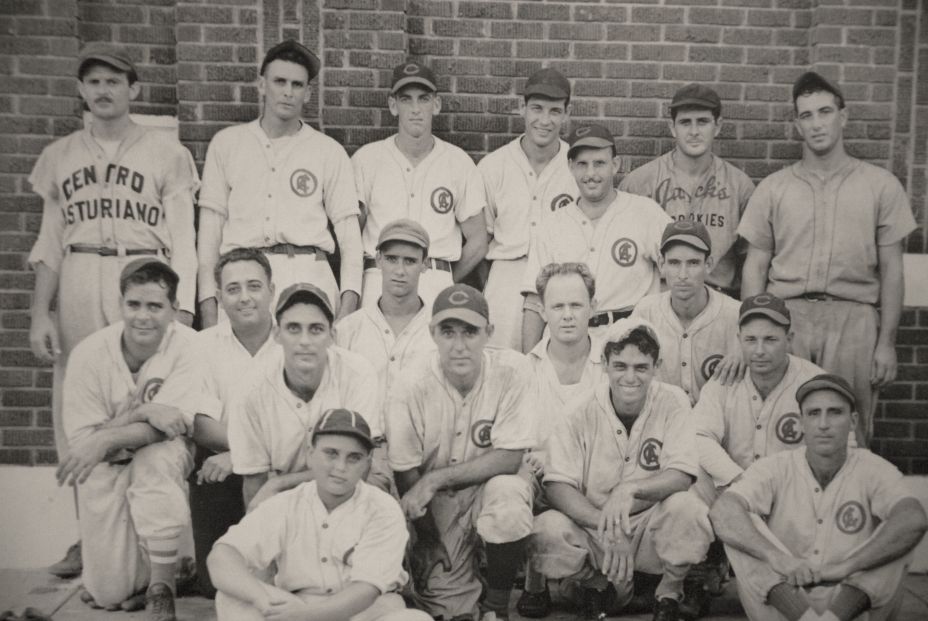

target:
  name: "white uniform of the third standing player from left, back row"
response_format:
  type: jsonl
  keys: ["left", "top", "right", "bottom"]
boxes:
{"left": 351, "top": 136, "right": 484, "bottom": 307}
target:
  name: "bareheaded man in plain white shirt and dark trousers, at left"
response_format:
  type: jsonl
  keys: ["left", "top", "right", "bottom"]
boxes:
{"left": 190, "top": 248, "right": 280, "bottom": 597}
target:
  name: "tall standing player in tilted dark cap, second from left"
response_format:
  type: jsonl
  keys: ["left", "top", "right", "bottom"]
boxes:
{"left": 197, "top": 39, "right": 362, "bottom": 327}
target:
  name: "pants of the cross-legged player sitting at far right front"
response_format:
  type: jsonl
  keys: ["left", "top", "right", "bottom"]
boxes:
{"left": 725, "top": 514, "right": 910, "bottom": 621}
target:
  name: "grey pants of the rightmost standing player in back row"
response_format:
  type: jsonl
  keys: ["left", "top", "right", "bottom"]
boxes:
{"left": 786, "top": 298, "right": 880, "bottom": 447}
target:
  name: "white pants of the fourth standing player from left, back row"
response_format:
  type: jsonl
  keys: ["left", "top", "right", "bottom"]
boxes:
{"left": 483, "top": 257, "right": 528, "bottom": 351}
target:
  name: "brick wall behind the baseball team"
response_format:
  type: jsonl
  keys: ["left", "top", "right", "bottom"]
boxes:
{"left": 0, "top": 0, "right": 928, "bottom": 473}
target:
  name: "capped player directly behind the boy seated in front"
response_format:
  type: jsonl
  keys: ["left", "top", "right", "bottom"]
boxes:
{"left": 228, "top": 283, "right": 388, "bottom": 510}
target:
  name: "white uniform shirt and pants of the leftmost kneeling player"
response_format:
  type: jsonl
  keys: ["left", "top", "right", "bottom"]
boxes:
{"left": 63, "top": 322, "right": 200, "bottom": 606}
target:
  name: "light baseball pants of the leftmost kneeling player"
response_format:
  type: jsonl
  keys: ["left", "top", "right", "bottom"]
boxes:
{"left": 78, "top": 438, "right": 193, "bottom": 607}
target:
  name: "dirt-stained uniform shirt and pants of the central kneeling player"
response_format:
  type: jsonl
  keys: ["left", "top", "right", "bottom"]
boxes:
{"left": 384, "top": 349, "right": 537, "bottom": 619}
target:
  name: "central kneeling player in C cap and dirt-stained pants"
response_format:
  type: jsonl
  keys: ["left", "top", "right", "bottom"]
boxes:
{"left": 384, "top": 284, "right": 536, "bottom": 621}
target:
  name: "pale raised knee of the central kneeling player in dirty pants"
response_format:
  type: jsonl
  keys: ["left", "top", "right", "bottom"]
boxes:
{"left": 477, "top": 474, "right": 532, "bottom": 543}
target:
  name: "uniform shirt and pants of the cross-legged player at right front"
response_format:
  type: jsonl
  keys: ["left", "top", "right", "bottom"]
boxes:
{"left": 725, "top": 447, "right": 913, "bottom": 621}
